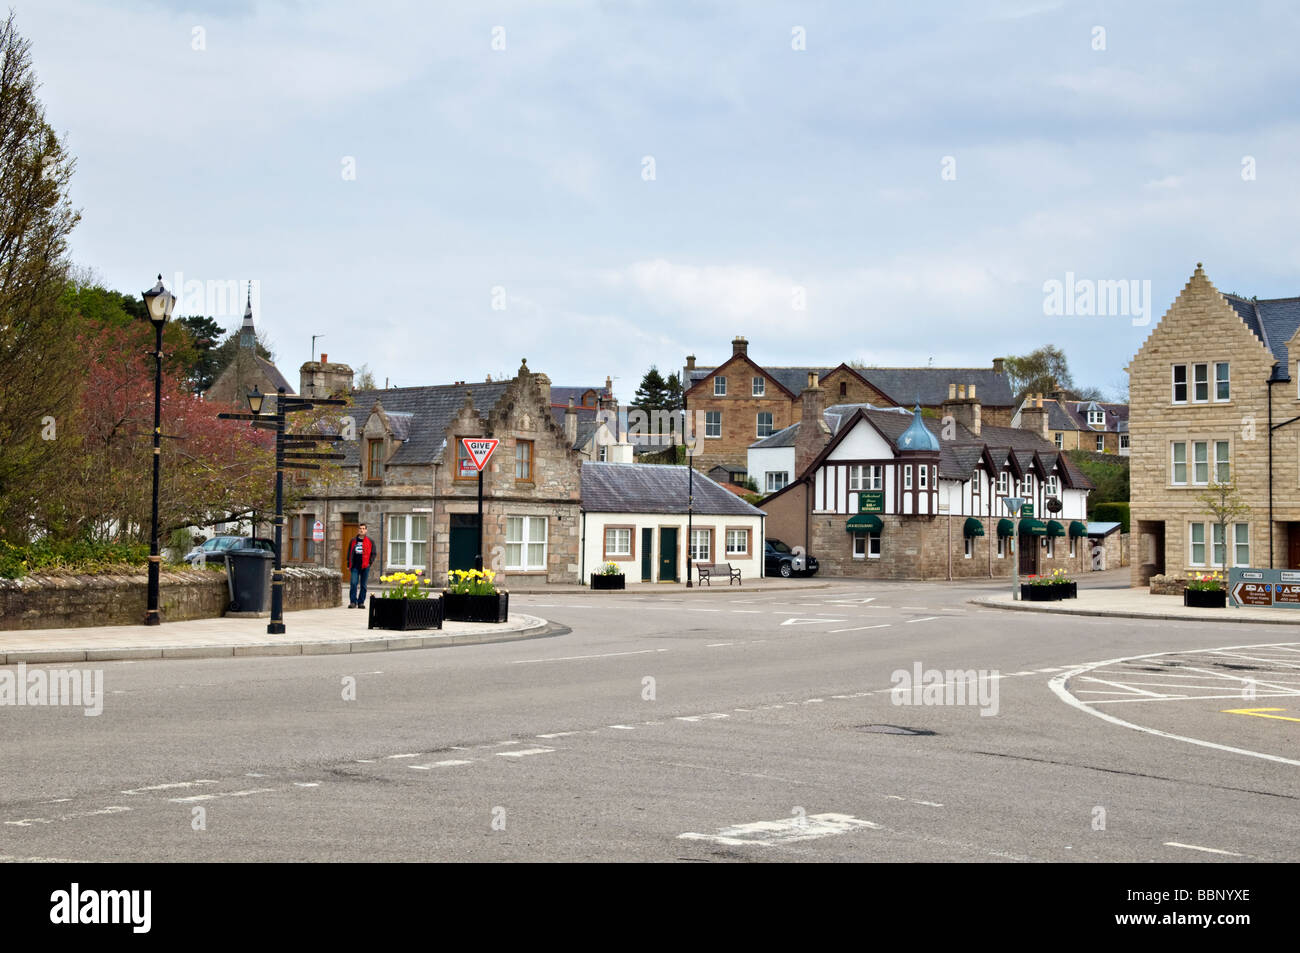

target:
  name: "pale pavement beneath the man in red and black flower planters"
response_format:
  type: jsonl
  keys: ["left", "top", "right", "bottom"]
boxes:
{"left": 0, "top": 606, "right": 558, "bottom": 664}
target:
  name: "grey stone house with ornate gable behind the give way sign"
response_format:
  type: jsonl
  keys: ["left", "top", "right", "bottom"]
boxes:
{"left": 297, "top": 361, "right": 582, "bottom": 585}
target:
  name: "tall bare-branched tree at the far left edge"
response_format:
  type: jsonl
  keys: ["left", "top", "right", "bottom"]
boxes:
{"left": 0, "top": 13, "right": 81, "bottom": 542}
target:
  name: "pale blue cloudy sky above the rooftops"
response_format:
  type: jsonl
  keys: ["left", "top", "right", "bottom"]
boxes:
{"left": 10, "top": 0, "right": 1300, "bottom": 400}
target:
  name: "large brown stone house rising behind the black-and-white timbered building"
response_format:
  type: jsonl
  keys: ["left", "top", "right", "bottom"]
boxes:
{"left": 681, "top": 337, "right": 1015, "bottom": 478}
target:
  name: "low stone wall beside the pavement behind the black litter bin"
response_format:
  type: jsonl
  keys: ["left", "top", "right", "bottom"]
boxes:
{"left": 0, "top": 568, "right": 343, "bottom": 629}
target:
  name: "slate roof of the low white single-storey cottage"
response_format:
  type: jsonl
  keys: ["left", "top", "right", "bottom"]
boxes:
{"left": 582, "top": 462, "right": 763, "bottom": 516}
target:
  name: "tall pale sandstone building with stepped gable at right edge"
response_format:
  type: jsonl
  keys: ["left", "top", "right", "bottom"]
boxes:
{"left": 1128, "top": 264, "right": 1300, "bottom": 585}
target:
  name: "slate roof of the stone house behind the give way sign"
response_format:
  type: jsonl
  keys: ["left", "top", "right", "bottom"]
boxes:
{"left": 341, "top": 381, "right": 508, "bottom": 467}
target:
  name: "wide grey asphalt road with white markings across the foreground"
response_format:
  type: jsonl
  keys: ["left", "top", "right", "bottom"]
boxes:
{"left": 0, "top": 572, "right": 1300, "bottom": 862}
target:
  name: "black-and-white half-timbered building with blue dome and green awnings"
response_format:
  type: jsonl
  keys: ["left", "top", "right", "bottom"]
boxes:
{"left": 759, "top": 374, "right": 1091, "bottom": 579}
